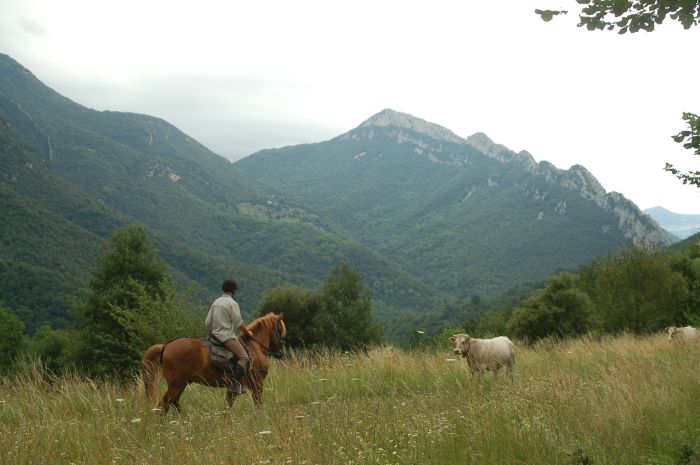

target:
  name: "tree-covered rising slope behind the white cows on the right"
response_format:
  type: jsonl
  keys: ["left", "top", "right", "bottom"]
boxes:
{"left": 410, "top": 239, "right": 700, "bottom": 346}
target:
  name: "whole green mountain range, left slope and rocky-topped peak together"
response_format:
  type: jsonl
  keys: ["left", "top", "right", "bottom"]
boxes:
{"left": 0, "top": 54, "right": 669, "bottom": 334}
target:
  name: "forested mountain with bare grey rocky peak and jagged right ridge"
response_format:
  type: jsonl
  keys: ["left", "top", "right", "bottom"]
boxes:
{"left": 234, "top": 109, "right": 670, "bottom": 298}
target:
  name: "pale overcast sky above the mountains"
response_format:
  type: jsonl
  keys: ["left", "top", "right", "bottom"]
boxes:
{"left": 0, "top": 0, "right": 700, "bottom": 214}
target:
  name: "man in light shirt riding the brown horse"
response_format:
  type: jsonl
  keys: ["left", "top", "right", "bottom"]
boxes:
{"left": 204, "top": 279, "right": 253, "bottom": 394}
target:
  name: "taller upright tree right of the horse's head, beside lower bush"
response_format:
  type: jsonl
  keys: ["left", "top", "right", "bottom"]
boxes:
{"left": 322, "top": 262, "right": 382, "bottom": 350}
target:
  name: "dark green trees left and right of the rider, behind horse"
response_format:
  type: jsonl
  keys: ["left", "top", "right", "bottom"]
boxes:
{"left": 0, "top": 225, "right": 382, "bottom": 380}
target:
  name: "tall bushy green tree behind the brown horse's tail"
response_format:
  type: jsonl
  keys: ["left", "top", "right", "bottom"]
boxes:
{"left": 75, "top": 225, "right": 169, "bottom": 378}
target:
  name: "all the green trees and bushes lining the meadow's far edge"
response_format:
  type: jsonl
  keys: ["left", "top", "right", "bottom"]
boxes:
{"left": 0, "top": 225, "right": 700, "bottom": 380}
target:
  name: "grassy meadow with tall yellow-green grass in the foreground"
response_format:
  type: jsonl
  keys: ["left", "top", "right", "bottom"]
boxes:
{"left": 0, "top": 336, "right": 700, "bottom": 465}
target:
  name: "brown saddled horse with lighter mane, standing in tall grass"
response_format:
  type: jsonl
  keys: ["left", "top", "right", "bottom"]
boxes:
{"left": 141, "top": 313, "right": 287, "bottom": 413}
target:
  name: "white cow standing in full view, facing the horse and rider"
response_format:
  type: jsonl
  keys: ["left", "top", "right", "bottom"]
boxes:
{"left": 450, "top": 334, "right": 515, "bottom": 379}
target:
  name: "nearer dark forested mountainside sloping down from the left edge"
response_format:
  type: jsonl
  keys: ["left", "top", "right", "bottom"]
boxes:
{"left": 0, "top": 54, "right": 445, "bottom": 330}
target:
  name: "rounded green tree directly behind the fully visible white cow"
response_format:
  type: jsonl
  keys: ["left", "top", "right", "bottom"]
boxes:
{"left": 508, "top": 272, "right": 593, "bottom": 339}
